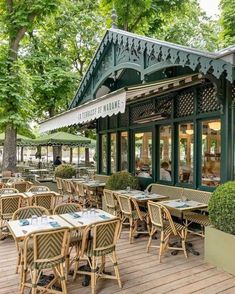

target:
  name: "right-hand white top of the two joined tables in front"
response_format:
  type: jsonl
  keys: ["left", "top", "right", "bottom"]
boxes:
{"left": 60, "top": 208, "right": 117, "bottom": 228}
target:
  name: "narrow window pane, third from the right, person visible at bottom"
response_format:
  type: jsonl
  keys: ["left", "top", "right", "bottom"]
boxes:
{"left": 160, "top": 126, "right": 171, "bottom": 181}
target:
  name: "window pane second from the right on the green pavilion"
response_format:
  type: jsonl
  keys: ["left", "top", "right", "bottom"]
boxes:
{"left": 179, "top": 123, "right": 194, "bottom": 183}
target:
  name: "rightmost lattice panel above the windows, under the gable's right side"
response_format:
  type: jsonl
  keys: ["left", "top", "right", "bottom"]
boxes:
{"left": 197, "top": 85, "right": 220, "bottom": 113}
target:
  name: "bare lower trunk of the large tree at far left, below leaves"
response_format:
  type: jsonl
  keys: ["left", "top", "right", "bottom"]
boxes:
{"left": 2, "top": 124, "right": 17, "bottom": 172}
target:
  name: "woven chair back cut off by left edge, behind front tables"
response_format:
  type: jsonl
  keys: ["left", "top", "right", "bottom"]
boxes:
{"left": 0, "top": 194, "right": 23, "bottom": 219}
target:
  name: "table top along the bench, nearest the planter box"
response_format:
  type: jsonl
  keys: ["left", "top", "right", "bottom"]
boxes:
{"left": 160, "top": 199, "right": 208, "bottom": 211}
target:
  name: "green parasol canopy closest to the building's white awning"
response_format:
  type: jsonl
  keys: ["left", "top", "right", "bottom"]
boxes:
{"left": 32, "top": 132, "right": 91, "bottom": 147}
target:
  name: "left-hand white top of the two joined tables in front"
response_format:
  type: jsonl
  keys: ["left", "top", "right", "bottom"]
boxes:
{"left": 8, "top": 215, "right": 73, "bottom": 240}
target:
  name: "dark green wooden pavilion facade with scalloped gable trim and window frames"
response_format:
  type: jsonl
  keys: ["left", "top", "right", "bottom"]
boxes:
{"left": 70, "top": 29, "right": 235, "bottom": 189}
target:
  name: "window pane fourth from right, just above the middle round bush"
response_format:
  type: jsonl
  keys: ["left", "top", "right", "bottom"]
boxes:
{"left": 135, "top": 132, "right": 152, "bottom": 178}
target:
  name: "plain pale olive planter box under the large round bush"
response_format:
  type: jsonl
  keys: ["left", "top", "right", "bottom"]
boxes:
{"left": 205, "top": 226, "right": 235, "bottom": 275}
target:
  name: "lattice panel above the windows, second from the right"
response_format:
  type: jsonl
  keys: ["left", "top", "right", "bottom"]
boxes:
{"left": 175, "top": 91, "right": 194, "bottom": 117}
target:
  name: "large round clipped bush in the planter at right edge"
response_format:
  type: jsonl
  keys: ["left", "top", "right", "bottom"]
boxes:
{"left": 208, "top": 181, "right": 235, "bottom": 235}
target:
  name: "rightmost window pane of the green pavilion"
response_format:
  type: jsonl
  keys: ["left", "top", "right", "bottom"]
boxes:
{"left": 202, "top": 120, "right": 221, "bottom": 186}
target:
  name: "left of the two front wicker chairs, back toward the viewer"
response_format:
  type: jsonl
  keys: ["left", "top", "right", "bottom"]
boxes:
{"left": 20, "top": 228, "right": 69, "bottom": 294}
